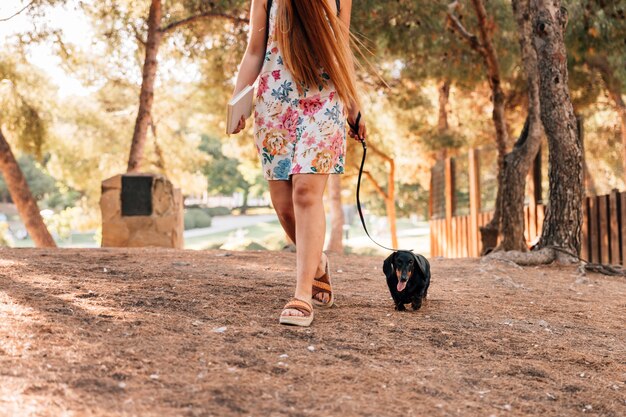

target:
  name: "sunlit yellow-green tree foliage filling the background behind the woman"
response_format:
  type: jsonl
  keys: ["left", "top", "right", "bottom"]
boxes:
{"left": 0, "top": 0, "right": 626, "bottom": 228}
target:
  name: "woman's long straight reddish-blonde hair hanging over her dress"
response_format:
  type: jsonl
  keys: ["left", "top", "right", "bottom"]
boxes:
{"left": 274, "top": 0, "right": 359, "bottom": 106}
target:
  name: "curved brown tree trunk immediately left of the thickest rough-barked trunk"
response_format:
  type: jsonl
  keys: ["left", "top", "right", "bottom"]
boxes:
{"left": 497, "top": 0, "right": 543, "bottom": 252}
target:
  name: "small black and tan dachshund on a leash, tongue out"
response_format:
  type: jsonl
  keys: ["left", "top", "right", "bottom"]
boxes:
{"left": 383, "top": 251, "right": 430, "bottom": 311}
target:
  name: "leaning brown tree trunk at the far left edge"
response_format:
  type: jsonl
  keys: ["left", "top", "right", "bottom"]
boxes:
{"left": 0, "top": 130, "right": 56, "bottom": 248}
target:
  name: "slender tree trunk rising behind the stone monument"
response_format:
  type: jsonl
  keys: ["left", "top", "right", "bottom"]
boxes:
{"left": 127, "top": 0, "right": 163, "bottom": 172}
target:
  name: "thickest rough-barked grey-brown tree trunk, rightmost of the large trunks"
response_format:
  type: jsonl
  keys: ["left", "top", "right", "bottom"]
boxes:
{"left": 531, "top": 0, "right": 583, "bottom": 263}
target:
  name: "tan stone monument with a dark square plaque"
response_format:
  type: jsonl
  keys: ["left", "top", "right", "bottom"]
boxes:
{"left": 100, "top": 173, "right": 184, "bottom": 249}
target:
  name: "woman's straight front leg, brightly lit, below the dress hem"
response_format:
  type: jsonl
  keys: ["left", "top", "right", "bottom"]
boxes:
{"left": 283, "top": 174, "right": 328, "bottom": 316}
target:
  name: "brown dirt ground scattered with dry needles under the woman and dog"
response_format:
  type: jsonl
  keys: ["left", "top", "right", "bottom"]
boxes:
{"left": 0, "top": 249, "right": 626, "bottom": 417}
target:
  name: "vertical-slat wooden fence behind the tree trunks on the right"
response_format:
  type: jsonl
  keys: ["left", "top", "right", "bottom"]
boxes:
{"left": 430, "top": 149, "right": 626, "bottom": 266}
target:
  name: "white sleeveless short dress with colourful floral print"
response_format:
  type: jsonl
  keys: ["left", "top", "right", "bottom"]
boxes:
{"left": 254, "top": 0, "right": 346, "bottom": 180}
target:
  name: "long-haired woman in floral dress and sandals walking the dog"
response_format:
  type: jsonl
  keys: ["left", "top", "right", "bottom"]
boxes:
{"left": 233, "top": 0, "right": 366, "bottom": 326}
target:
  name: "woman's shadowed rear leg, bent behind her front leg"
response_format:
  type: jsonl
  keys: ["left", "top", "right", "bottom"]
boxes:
{"left": 268, "top": 180, "right": 330, "bottom": 303}
